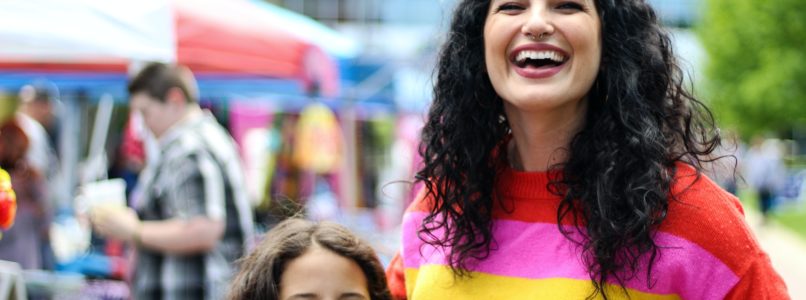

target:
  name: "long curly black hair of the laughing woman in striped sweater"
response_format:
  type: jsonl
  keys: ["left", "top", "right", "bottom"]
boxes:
{"left": 417, "top": 0, "right": 720, "bottom": 298}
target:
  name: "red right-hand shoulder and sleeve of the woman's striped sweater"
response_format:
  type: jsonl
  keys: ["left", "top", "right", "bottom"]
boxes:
{"left": 660, "top": 163, "right": 786, "bottom": 299}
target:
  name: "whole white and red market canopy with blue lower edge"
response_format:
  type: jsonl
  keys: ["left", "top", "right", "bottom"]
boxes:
{"left": 0, "top": 0, "right": 338, "bottom": 98}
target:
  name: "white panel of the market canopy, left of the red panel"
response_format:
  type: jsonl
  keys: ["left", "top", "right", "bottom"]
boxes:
{"left": 0, "top": 0, "right": 176, "bottom": 70}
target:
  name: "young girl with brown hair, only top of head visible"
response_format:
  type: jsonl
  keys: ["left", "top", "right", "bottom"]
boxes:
{"left": 228, "top": 219, "right": 391, "bottom": 300}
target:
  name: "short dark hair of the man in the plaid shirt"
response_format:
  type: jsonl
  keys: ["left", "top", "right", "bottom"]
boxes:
{"left": 128, "top": 62, "right": 198, "bottom": 102}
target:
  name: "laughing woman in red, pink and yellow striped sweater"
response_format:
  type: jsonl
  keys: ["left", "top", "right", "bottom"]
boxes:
{"left": 387, "top": 0, "right": 788, "bottom": 299}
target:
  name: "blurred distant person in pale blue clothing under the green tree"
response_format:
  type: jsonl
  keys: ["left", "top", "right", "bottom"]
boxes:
{"left": 741, "top": 136, "right": 786, "bottom": 225}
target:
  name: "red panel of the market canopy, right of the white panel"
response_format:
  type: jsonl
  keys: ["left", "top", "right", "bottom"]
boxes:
{"left": 174, "top": 0, "right": 311, "bottom": 78}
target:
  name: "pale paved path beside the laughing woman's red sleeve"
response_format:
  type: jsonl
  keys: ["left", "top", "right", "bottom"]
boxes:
{"left": 747, "top": 212, "right": 806, "bottom": 300}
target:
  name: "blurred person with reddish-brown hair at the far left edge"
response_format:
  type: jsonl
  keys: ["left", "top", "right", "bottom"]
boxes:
{"left": 0, "top": 118, "right": 52, "bottom": 269}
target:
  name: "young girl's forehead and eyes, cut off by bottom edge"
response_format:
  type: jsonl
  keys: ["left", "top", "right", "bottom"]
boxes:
{"left": 280, "top": 247, "right": 370, "bottom": 300}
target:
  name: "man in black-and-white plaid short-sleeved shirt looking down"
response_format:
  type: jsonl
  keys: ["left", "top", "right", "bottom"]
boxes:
{"left": 90, "top": 63, "right": 253, "bottom": 299}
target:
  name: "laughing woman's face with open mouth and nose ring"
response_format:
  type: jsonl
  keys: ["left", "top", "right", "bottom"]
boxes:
{"left": 484, "top": 0, "right": 602, "bottom": 111}
